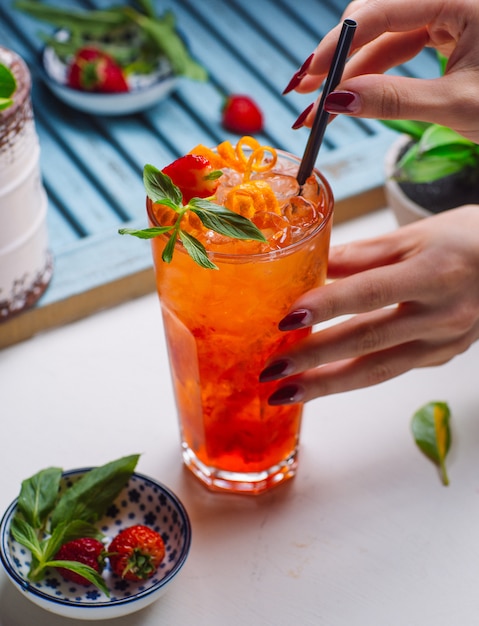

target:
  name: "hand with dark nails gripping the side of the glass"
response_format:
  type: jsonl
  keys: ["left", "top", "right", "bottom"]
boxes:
{"left": 261, "top": 206, "right": 479, "bottom": 404}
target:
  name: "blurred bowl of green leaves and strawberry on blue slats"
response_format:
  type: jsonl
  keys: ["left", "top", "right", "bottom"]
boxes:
{"left": 14, "top": 0, "right": 207, "bottom": 115}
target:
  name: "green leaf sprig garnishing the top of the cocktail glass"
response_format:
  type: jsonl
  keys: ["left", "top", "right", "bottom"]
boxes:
{"left": 118, "top": 165, "right": 267, "bottom": 269}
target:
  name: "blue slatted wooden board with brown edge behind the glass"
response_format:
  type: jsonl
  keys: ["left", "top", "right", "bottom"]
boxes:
{"left": 0, "top": 0, "right": 437, "bottom": 347}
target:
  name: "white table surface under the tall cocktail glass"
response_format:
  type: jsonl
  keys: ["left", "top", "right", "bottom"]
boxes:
{"left": 0, "top": 210, "right": 479, "bottom": 626}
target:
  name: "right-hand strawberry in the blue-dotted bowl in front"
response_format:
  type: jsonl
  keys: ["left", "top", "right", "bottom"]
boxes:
{"left": 108, "top": 524, "right": 165, "bottom": 581}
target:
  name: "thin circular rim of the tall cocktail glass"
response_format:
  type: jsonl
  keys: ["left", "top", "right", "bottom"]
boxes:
{"left": 146, "top": 150, "right": 334, "bottom": 263}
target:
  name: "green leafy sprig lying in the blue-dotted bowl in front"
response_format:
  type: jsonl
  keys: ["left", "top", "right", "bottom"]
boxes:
{"left": 10, "top": 454, "right": 139, "bottom": 596}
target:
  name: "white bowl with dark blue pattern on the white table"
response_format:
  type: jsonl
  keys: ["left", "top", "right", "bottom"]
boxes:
{"left": 0, "top": 468, "right": 191, "bottom": 620}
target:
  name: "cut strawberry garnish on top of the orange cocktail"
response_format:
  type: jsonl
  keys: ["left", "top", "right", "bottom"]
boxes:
{"left": 161, "top": 154, "right": 221, "bottom": 204}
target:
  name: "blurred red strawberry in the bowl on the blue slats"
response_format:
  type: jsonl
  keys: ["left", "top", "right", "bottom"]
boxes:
{"left": 67, "top": 47, "right": 129, "bottom": 93}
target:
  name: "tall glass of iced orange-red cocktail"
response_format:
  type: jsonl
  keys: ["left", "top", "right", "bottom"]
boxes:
{"left": 147, "top": 138, "right": 333, "bottom": 493}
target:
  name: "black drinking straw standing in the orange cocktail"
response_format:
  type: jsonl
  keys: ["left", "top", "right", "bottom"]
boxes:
{"left": 297, "top": 19, "right": 357, "bottom": 186}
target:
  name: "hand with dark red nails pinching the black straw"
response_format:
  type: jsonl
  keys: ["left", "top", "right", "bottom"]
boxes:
{"left": 285, "top": 0, "right": 479, "bottom": 143}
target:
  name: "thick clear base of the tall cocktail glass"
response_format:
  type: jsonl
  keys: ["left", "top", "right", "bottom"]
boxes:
{"left": 182, "top": 444, "right": 298, "bottom": 496}
